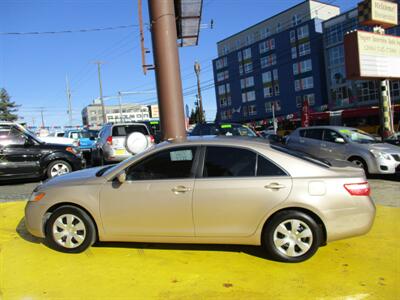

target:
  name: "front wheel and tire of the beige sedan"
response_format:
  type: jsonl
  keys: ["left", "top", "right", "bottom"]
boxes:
{"left": 45, "top": 205, "right": 97, "bottom": 253}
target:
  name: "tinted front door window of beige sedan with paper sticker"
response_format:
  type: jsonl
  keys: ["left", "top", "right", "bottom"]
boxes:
{"left": 126, "top": 147, "right": 197, "bottom": 181}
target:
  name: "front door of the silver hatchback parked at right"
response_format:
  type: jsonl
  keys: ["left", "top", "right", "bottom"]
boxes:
{"left": 320, "top": 129, "right": 347, "bottom": 160}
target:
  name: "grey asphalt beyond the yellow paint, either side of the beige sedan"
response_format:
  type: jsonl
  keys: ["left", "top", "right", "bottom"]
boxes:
{"left": 0, "top": 176, "right": 400, "bottom": 207}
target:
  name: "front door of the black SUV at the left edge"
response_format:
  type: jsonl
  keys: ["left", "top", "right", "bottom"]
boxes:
{"left": 0, "top": 126, "right": 41, "bottom": 179}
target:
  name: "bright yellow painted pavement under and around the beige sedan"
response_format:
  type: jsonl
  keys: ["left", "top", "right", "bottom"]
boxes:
{"left": 0, "top": 202, "right": 400, "bottom": 300}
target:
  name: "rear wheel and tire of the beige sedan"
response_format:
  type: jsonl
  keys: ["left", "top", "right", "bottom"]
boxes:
{"left": 262, "top": 210, "right": 323, "bottom": 263}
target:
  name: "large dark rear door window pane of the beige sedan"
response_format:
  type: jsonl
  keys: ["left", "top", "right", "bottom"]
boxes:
{"left": 203, "top": 146, "right": 257, "bottom": 178}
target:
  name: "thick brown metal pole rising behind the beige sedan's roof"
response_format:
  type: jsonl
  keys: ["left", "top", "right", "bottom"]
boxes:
{"left": 148, "top": 0, "right": 186, "bottom": 140}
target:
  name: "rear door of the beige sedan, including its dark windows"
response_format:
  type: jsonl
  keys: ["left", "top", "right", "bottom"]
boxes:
{"left": 193, "top": 146, "right": 292, "bottom": 237}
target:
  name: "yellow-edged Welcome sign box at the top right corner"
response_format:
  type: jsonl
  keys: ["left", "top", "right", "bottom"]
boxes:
{"left": 358, "top": 0, "right": 398, "bottom": 28}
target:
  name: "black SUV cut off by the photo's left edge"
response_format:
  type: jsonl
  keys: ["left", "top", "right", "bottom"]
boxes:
{"left": 0, "top": 122, "right": 85, "bottom": 181}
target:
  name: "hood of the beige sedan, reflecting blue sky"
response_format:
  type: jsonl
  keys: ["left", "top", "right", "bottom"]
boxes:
{"left": 43, "top": 166, "right": 105, "bottom": 188}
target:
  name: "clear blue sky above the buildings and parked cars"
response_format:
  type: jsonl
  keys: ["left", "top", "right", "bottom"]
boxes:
{"left": 0, "top": 0, "right": 358, "bottom": 126}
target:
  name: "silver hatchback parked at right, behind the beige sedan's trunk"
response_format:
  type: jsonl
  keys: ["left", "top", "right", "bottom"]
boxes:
{"left": 286, "top": 126, "right": 400, "bottom": 174}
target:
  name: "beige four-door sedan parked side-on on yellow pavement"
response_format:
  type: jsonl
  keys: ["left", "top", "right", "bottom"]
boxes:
{"left": 25, "top": 137, "right": 375, "bottom": 262}
